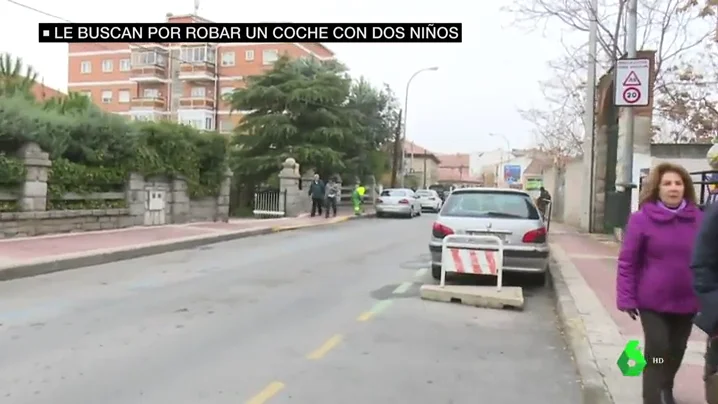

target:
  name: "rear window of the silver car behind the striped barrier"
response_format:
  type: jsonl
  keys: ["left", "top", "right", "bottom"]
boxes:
{"left": 441, "top": 192, "right": 539, "bottom": 219}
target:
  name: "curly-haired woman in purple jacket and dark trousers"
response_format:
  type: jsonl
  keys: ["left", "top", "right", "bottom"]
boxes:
{"left": 616, "top": 163, "right": 702, "bottom": 404}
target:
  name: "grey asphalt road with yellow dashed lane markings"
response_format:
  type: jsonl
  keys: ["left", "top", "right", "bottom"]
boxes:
{"left": 0, "top": 215, "right": 580, "bottom": 404}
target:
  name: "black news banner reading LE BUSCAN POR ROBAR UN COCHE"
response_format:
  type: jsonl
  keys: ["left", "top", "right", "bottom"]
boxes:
{"left": 39, "top": 23, "right": 462, "bottom": 43}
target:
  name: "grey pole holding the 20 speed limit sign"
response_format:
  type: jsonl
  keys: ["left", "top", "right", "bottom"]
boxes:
{"left": 616, "top": 0, "right": 638, "bottom": 191}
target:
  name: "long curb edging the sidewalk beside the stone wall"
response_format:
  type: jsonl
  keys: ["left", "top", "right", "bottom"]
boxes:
{"left": 0, "top": 213, "right": 376, "bottom": 282}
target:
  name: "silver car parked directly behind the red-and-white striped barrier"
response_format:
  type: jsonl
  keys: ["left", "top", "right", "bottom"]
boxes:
{"left": 429, "top": 188, "right": 549, "bottom": 282}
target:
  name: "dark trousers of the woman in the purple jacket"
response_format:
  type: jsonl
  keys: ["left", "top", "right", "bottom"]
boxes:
{"left": 641, "top": 310, "right": 693, "bottom": 404}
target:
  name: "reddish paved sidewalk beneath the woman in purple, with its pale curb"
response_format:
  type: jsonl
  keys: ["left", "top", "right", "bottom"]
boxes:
{"left": 550, "top": 223, "right": 705, "bottom": 404}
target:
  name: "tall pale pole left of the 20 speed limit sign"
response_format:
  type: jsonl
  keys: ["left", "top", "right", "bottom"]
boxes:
{"left": 580, "top": 0, "right": 598, "bottom": 232}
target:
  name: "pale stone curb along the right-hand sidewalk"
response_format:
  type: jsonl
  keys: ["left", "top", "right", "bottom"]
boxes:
{"left": 549, "top": 251, "right": 614, "bottom": 404}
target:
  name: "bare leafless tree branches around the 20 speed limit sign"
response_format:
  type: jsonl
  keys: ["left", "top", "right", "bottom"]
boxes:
{"left": 507, "top": 0, "right": 718, "bottom": 148}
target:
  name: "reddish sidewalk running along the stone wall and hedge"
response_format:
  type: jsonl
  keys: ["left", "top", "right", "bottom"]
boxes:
{"left": 0, "top": 212, "right": 373, "bottom": 281}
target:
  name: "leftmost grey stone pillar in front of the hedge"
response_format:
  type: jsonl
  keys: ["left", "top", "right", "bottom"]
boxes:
{"left": 18, "top": 142, "right": 52, "bottom": 212}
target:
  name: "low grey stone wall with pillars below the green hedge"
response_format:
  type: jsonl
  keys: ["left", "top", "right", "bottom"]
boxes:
{"left": 0, "top": 143, "right": 232, "bottom": 238}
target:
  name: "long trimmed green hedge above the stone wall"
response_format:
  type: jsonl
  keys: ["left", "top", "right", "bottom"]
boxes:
{"left": 0, "top": 96, "right": 228, "bottom": 210}
